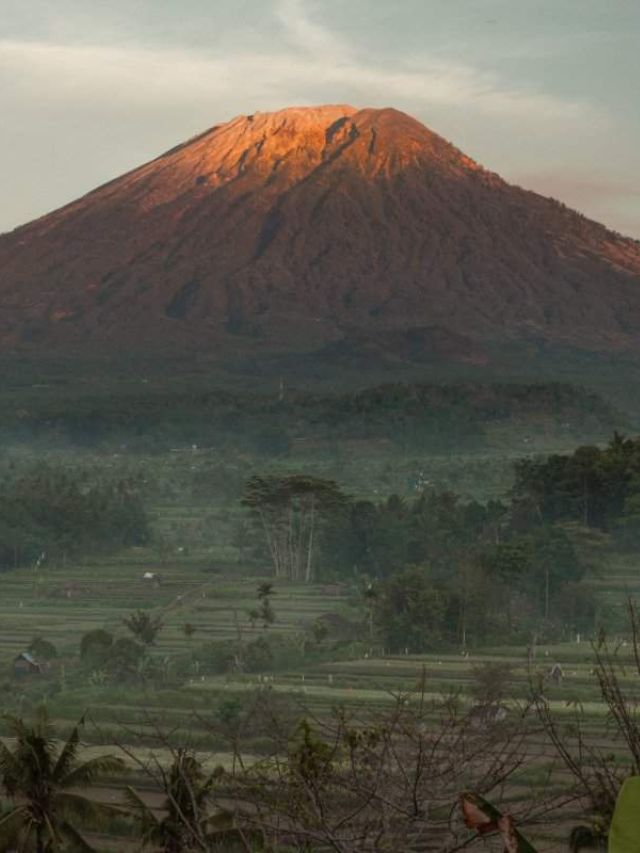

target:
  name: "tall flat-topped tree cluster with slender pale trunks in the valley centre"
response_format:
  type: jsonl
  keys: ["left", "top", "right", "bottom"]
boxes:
{"left": 242, "top": 474, "right": 346, "bottom": 583}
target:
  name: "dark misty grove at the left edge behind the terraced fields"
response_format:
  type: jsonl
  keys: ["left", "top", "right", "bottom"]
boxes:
{"left": 0, "top": 464, "right": 149, "bottom": 569}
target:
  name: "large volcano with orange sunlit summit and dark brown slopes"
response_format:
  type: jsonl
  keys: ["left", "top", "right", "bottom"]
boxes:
{"left": 0, "top": 105, "right": 640, "bottom": 362}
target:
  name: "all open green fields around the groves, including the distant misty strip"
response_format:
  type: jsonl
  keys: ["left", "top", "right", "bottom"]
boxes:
{"left": 0, "top": 396, "right": 640, "bottom": 851}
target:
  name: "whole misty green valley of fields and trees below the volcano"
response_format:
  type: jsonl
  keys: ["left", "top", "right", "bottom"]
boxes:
{"left": 0, "top": 378, "right": 640, "bottom": 853}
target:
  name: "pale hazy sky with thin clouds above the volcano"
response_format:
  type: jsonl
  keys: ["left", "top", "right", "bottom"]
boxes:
{"left": 0, "top": 0, "right": 640, "bottom": 238}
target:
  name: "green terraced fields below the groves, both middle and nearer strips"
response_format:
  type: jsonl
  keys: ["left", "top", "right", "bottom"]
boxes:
{"left": 0, "top": 549, "right": 640, "bottom": 851}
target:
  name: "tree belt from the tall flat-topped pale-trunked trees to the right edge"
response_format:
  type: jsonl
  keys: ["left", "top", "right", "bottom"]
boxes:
{"left": 244, "top": 446, "right": 628, "bottom": 652}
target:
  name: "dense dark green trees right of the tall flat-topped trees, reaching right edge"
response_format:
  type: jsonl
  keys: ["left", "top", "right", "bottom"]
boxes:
{"left": 356, "top": 440, "right": 640, "bottom": 650}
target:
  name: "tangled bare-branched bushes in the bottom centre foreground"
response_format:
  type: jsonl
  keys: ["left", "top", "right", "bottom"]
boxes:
{"left": 228, "top": 675, "right": 536, "bottom": 853}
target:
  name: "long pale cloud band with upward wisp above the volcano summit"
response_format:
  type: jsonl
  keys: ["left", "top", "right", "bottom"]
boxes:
{"left": 0, "top": 0, "right": 594, "bottom": 121}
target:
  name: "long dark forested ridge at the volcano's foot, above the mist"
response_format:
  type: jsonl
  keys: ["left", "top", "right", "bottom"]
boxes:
{"left": 0, "top": 383, "right": 620, "bottom": 456}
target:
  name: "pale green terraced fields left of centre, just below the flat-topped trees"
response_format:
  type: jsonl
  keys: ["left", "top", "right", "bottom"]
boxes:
{"left": 0, "top": 549, "right": 346, "bottom": 668}
